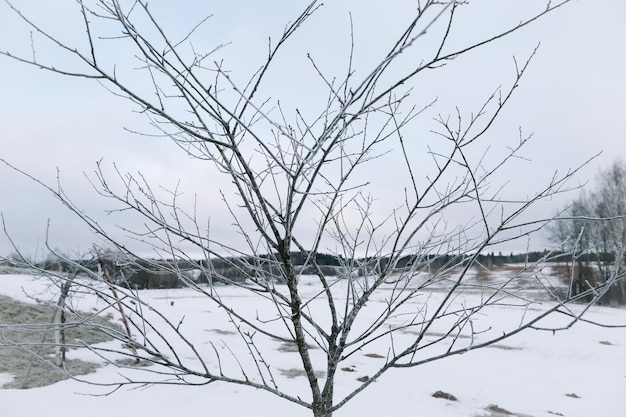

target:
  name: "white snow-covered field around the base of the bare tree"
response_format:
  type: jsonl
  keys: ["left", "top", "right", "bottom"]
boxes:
{"left": 0, "top": 275, "right": 626, "bottom": 417}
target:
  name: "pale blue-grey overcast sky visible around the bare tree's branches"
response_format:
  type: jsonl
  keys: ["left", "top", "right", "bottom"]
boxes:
{"left": 0, "top": 0, "right": 626, "bottom": 255}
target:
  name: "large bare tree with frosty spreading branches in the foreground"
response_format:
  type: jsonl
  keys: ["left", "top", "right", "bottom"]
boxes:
{"left": 1, "top": 0, "right": 622, "bottom": 417}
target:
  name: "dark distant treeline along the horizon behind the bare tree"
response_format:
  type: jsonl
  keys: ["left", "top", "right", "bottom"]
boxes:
{"left": 13, "top": 247, "right": 566, "bottom": 289}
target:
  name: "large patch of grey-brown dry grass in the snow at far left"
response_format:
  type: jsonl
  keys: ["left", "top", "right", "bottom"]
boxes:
{"left": 0, "top": 295, "right": 123, "bottom": 389}
